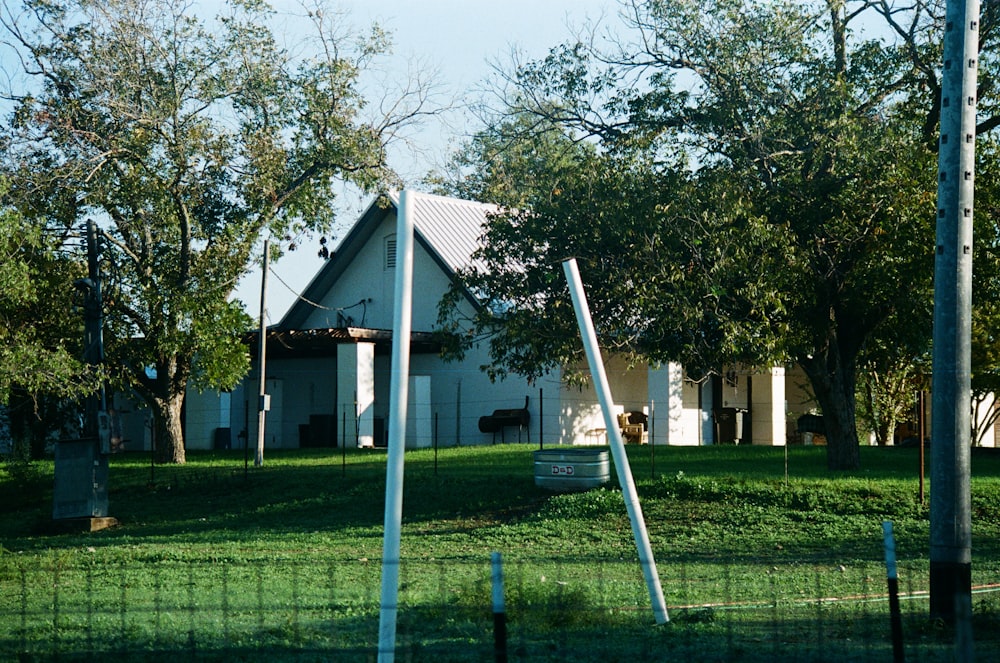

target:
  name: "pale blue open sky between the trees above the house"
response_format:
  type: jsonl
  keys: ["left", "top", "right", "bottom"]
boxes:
{"left": 236, "top": 0, "right": 619, "bottom": 324}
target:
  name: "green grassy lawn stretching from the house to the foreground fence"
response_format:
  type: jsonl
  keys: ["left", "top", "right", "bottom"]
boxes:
{"left": 0, "top": 445, "right": 1000, "bottom": 661}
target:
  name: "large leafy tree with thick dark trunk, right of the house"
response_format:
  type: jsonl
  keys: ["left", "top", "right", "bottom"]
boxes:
{"left": 438, "top": 0, "right": 992, "bottom": 469}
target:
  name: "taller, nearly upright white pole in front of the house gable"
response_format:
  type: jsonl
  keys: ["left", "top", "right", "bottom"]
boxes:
{"left": 378, "top": 191, "right": 413, "bottom": 663}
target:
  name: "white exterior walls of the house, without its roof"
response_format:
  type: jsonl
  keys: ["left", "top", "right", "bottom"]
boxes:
{"left": 170, "top": 196, "right": 995, "bottom": 456}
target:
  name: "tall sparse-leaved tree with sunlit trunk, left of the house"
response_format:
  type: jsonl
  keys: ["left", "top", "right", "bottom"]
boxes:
{"left": 2, "top": 0, "right": 428, "bottom": 463}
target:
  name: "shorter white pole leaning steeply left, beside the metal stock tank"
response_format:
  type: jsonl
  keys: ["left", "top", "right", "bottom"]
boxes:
{"left": 563, "top": 259, "right": 669, "bottom": 624}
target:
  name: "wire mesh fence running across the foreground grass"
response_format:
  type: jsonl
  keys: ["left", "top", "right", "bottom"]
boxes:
{"left": 0, "top": 550, "right": 1000, "bottom": 663}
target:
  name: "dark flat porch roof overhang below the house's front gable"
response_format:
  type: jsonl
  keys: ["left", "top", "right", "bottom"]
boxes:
{"left": 244, "top": 327, "right": 441, "bottom": 359}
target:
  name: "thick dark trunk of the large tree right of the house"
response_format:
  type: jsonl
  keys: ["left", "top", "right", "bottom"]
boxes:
{"left": 800, "top": 353, "right": 861, "bottom": 470}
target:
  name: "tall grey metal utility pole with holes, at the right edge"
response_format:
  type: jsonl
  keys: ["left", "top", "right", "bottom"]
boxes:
{"left": 930, "top": 0, "right": 979, "bottom": 622}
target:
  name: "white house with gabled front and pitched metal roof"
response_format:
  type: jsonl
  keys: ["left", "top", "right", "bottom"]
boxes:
{"left": 125, "top": 193, "right": 992, "bottom": 449}
